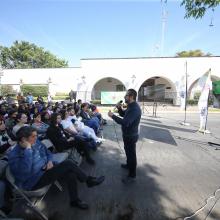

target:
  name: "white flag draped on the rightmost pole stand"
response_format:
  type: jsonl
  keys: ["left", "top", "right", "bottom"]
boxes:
{"left": 198, "top": 70, "right": 212, "bottom": 131}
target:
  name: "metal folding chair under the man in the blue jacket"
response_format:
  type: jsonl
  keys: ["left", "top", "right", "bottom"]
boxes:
{"left": 6, "top": 166, "right": 62, "bottom": 220}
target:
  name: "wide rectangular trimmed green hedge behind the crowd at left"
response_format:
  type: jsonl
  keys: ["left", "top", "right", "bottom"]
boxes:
{"left": 21, "top": 85, "right": 48, "bottom": 97}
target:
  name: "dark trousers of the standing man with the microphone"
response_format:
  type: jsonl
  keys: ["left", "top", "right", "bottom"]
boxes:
{"left": 123, "top": 135, "right": 138, "bottom": 177}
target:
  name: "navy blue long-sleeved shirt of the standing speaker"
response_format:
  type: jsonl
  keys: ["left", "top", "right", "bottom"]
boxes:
{"left": 112, "top": 102, "right": 141, "bottom": 137}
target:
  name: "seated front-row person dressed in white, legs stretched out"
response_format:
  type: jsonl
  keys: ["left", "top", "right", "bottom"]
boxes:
{"left": 67, "top": 108, "right": 104, "bottom": 144}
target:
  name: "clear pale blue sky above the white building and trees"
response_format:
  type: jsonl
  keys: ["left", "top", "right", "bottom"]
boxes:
{"left": 0, "top": 0, "right": 220, "bottom": 67}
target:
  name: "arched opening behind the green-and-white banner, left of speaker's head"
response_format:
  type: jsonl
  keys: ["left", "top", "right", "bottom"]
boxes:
{"left": 92, "top": 77, "right": 126, "bottom": 100}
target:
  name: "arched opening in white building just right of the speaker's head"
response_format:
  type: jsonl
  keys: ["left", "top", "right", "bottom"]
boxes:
{"left": 138, "top": 76, "right": 177, "bottom": 104}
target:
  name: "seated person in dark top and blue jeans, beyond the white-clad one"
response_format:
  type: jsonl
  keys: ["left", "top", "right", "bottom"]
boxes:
{"left": 80, "top": 103, "right": 100, "bottom": 134}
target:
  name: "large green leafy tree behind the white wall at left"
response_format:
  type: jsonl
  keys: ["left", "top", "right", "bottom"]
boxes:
{"left": 0, "top": 41, "right": 68, "bottom": 68}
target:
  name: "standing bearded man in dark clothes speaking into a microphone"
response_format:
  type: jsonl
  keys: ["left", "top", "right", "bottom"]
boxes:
{"left": 108, "top": 89, "right": 141, "bottom": 184}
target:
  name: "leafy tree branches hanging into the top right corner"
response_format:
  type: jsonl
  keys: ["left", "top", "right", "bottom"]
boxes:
{"left": 181, "top": 0, "right": 220, "bottom": 19}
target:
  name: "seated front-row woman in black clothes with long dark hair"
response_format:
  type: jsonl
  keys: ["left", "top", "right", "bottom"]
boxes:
{"left": 47, "top": 113, "right": 95, "bottom": 164}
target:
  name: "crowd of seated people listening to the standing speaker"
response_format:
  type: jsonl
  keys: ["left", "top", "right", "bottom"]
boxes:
{"left": 0, "top": 95, "right": 105, "bottom": 217}
